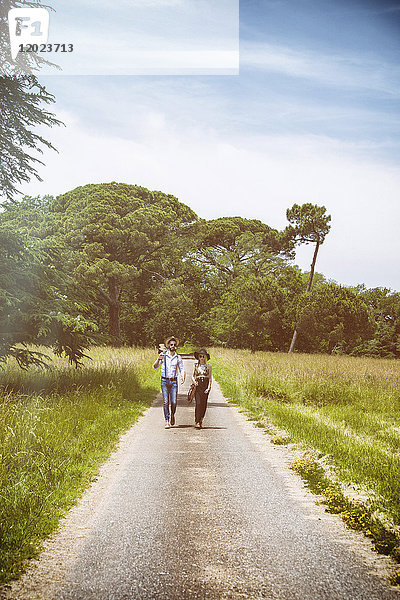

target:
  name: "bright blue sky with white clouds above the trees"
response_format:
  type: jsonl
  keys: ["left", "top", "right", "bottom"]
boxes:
{"left": 14, "top": 0, "right": 400, "bottom": 291}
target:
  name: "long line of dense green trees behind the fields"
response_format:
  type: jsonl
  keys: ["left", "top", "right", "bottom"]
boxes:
{"left": 0, "top": 183, "right": 400, "bottom": 365}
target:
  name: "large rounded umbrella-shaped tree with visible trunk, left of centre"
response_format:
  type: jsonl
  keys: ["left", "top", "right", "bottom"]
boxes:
{"left": 53, "top": 182, "right": 197, "bottom": 345}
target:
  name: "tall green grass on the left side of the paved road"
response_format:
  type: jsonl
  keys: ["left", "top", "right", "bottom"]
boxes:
{"left": 0, "top": 348, "right": 158, "bottom": 582}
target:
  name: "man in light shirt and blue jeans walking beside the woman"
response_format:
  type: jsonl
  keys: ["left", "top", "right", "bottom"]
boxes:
{"left": 153, "top": 336, "right": 186, "bottom": 429}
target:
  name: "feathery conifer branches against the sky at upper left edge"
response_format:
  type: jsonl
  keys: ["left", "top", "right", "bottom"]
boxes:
{"left": 0, "top": 0, "right": 62, "bottom": 200}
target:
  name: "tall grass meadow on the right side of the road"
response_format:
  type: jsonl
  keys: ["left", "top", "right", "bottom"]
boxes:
{"left": 213, "top": 349, "right": 400, "bottom": 527}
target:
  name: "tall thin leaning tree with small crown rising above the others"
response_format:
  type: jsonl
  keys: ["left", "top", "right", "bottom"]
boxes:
{"left": 286, "top": 203, "right": 331, "bottom": 352}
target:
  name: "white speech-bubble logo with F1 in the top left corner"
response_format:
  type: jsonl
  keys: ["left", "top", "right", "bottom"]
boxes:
{"left": 8, "top": 8, "right": 50, "bottom": 60}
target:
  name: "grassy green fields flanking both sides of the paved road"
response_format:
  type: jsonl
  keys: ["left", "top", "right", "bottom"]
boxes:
{"left": 0, "top": 348, "right": 400, "bottom": 582}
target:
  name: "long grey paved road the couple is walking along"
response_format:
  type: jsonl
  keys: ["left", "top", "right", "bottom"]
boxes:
{"left": 3, "top": 360, "right": 399, "bottom": 600}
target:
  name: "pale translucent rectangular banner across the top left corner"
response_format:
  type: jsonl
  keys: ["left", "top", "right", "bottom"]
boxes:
{"left": 3, "top": 0, "right": 239, "bottom": 75}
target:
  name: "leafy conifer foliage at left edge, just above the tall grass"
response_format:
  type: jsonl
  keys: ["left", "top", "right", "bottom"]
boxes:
{"left": 0, "top": 197, "right": 96, "bottom": 368}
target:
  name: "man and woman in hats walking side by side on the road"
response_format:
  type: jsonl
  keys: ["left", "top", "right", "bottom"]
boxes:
{"left": 153, "top": 336, "right": 212, "bottom": 429}
